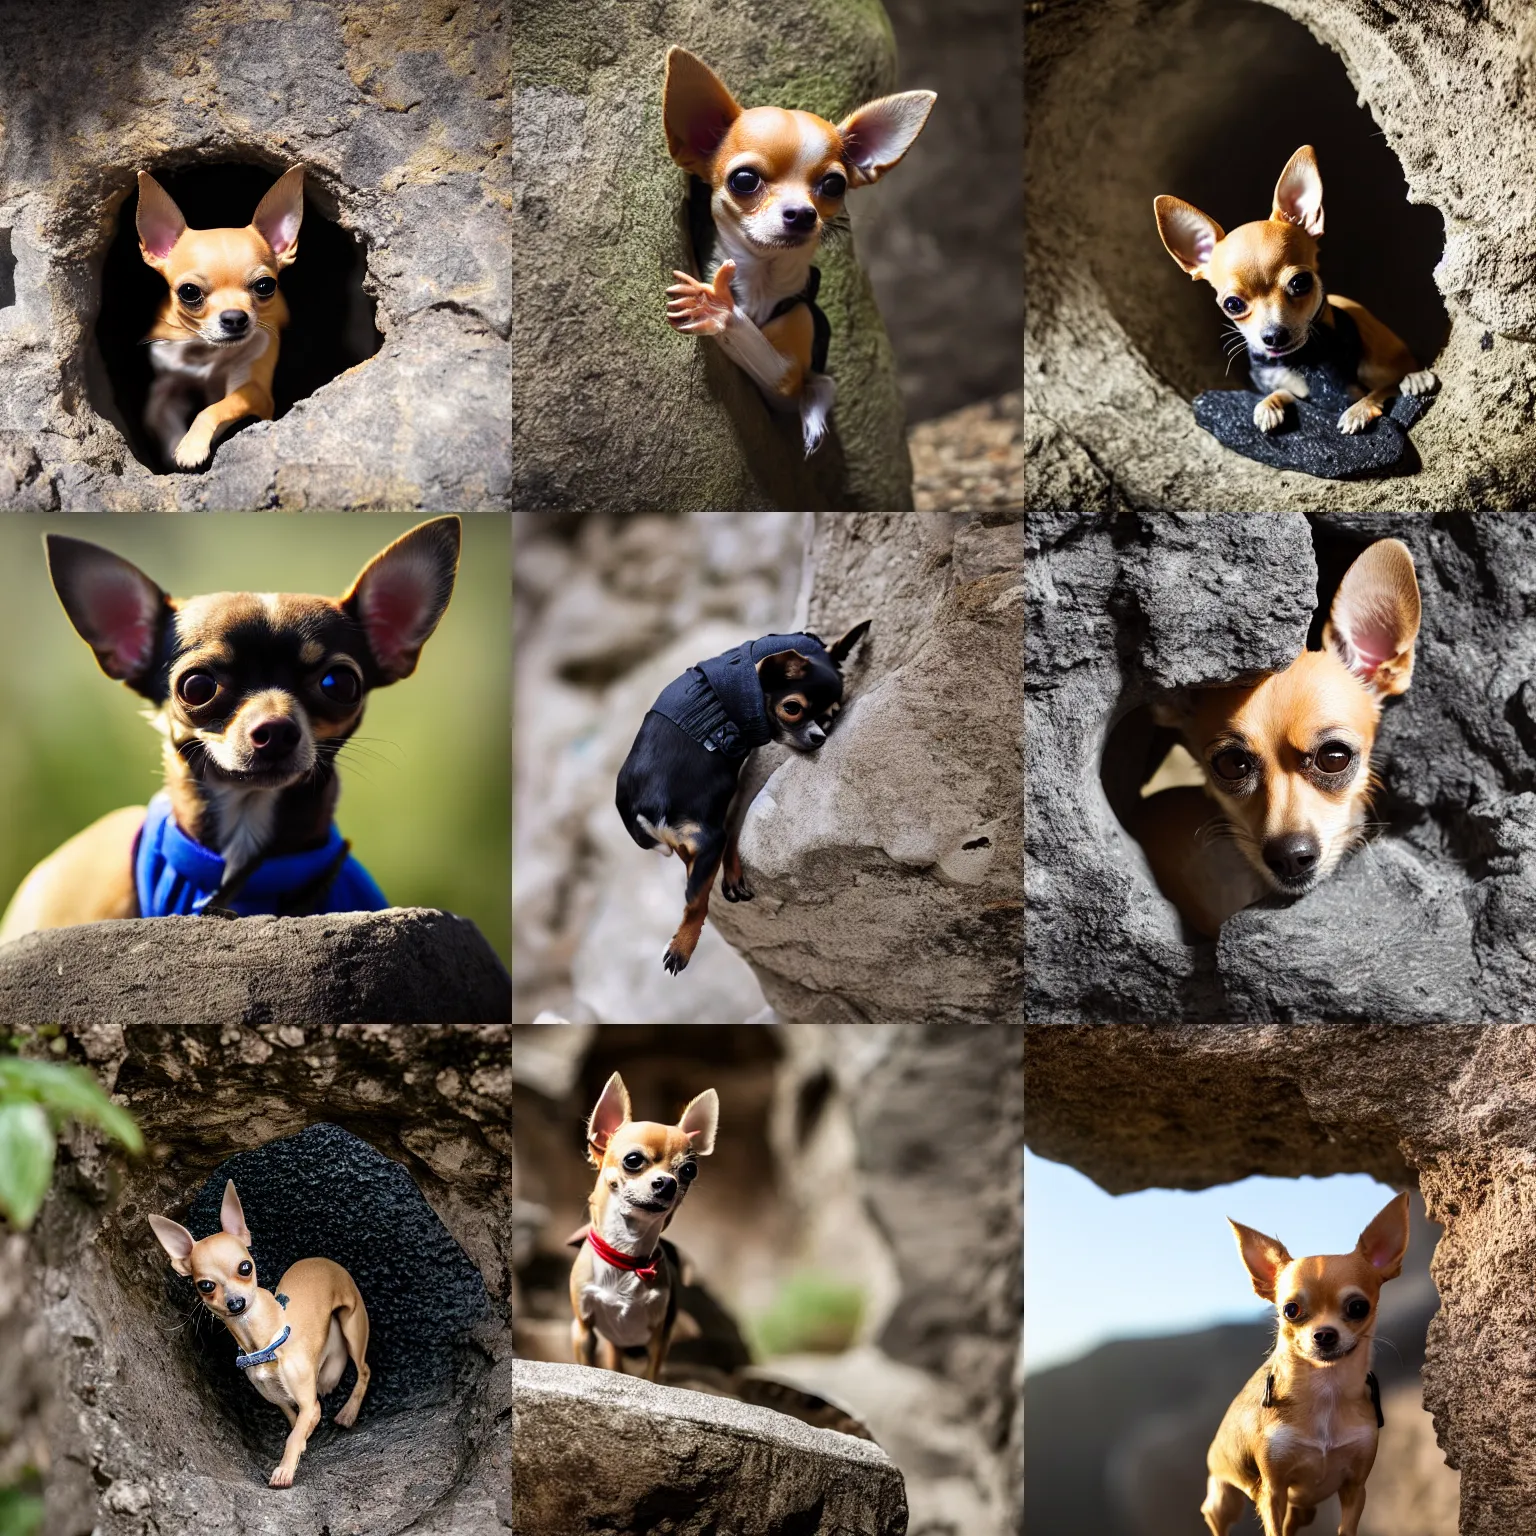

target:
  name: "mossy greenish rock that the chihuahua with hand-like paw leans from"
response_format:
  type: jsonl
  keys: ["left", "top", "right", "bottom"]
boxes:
{"left": 511, "top": 0, "right": 923, "bottom": 511}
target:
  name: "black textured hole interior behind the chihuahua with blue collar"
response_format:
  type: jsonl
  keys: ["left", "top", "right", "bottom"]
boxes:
{"left": 166, "top": 1123, "right": 488, "bottom": 1462}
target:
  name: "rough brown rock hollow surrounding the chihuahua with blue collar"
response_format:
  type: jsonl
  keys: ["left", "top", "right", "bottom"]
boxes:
{"left": 12, "top": 1023, "right": 511, "bottom": 1536}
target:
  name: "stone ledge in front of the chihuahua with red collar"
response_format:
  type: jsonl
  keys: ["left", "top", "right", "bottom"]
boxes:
{"left": 511, "top": 1361, "right": 906, "bottom": 1536}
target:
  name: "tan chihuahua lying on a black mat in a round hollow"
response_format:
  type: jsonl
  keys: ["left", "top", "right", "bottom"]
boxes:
{"left": 1152, "top": 144, "right": 1439, "bottom": 433}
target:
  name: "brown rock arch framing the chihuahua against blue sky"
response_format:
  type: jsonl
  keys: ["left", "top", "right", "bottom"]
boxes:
{"left": 1026, "top": 1025, "right": 1536, "bottom": 1536}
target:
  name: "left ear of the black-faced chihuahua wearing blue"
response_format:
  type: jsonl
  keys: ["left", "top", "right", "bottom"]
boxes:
{"left": 43, "top": 533, "right": 174, "bottom": 702}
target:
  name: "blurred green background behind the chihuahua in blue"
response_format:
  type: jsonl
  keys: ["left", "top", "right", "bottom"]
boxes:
{"left": 0, "top": 513, "right": 511, "bottom": 963}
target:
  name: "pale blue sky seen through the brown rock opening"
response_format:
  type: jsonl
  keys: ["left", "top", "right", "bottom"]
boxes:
{"left": 1025, "top": 1152, "right": 1395, "bottom": 1372}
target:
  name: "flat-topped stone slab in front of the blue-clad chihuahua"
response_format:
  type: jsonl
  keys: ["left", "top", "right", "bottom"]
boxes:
{"left": 0, "top": 908, "right": 511, "bottom": 1028}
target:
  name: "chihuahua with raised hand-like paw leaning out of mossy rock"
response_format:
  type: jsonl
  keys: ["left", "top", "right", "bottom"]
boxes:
{"left": 662, "top": 48, "right": 937, "bottom": 458}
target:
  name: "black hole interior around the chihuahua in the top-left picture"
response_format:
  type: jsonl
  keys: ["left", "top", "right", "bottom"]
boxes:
{"left": 89, "top": 164, "right": 384, "bottom": 473}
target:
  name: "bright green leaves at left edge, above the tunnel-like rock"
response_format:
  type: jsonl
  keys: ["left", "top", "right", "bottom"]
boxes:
{"left": 0, "top": 1057, "right": 144, "bottom": 1228}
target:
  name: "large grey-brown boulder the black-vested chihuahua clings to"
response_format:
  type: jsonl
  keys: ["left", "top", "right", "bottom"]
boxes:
{"left": 710, "top": 510, "right": 1025, "bottom": 1023}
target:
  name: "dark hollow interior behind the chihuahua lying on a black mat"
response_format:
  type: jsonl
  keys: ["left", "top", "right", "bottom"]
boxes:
{"left": 1064, "top": 0, "right": 1450, "bottom": 399}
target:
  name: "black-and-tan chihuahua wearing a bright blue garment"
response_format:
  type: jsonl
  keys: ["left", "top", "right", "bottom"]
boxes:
{"left": 0, "top": 518, "right": 459, "bottom": 942}
